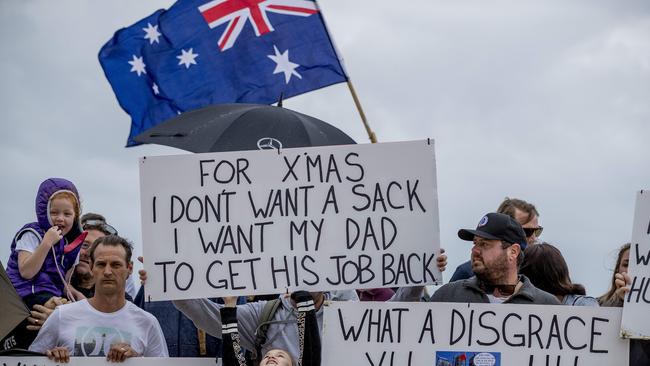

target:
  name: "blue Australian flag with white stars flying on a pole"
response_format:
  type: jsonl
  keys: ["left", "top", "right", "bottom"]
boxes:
{"left": 99, "top": 0, "right": 348, "bottom": 146}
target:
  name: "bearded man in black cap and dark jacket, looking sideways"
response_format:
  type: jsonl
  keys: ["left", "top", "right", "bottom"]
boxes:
{"left": 431, "top": 212, "right": 560, "bottom": 305}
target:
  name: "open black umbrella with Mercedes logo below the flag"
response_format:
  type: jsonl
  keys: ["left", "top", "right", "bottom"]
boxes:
{"left": 135, "top": 104, "right": 355, "bottom": 152}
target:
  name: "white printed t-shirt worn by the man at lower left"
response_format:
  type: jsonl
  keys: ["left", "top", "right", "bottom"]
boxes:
{"left": 29, "top": 300, "right": 169, "bottom": 357}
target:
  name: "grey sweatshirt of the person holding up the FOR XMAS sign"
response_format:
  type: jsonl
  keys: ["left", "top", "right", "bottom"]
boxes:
{"left": 173, "top": 286, "right": 423, "bottom": 360}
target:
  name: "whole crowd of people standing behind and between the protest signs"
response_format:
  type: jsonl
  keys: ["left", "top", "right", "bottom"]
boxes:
{"left": 0, "top": 178, "right": 650, "bottom": 366}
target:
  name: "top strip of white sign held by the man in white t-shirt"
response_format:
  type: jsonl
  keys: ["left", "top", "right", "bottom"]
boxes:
{"left": 0, "top": 356, "right": 222, "bottom": 366}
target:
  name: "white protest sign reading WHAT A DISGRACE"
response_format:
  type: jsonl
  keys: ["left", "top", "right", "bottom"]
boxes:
{"left": 322, "top": 302, "right": 629, "bottom": 366}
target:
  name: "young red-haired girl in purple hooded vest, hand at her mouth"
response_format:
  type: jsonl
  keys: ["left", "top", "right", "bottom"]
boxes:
{"left": 7, "top": 178, "right": 82, "bottom": 309}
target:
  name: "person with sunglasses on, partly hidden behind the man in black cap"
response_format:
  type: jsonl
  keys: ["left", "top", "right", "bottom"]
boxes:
{"left": 449, "top": 197, "right": 544, "bottom": 282}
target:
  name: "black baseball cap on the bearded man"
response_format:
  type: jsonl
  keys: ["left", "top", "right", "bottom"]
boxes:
{"left": 458, "top": 212, "right": 526, "bottom": 250}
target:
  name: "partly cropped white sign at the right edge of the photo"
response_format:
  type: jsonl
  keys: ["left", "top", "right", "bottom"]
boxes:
{"left": 621, "top": 190, "right": 650, "bottom": 339}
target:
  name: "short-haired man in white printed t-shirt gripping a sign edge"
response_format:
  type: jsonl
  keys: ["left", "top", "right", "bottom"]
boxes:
{"left": 29, "top": 235, "right": 168, "bottom": 362}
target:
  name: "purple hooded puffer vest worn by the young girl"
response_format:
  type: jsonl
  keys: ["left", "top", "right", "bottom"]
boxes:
{"left": 7, "top": 178, "right": 81, "bottom": 298}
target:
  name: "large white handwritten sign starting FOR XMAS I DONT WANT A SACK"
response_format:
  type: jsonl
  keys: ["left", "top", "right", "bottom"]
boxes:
{"left": 140, "top": 140, "right": 441, "bottom": 300}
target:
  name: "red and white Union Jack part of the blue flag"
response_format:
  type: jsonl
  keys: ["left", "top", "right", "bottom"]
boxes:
{"left": 199, "top": 0, "right": 318, "bottom": 51}
